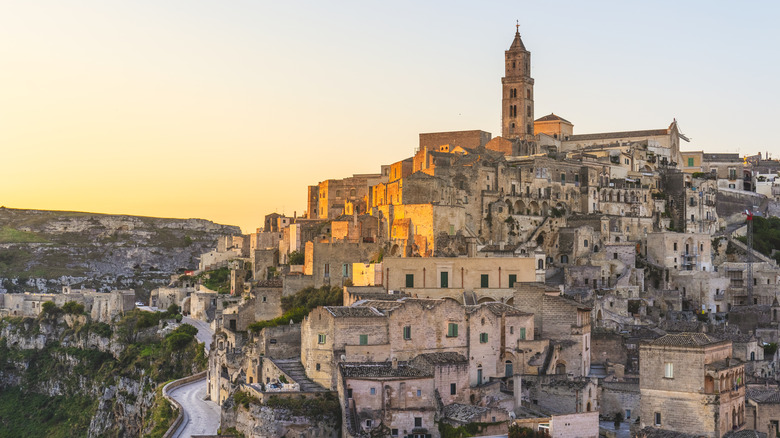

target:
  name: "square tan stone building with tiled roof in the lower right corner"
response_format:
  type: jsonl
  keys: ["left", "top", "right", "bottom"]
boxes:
{"left": 639, "top": 333, "right": 745, "bottom": 437}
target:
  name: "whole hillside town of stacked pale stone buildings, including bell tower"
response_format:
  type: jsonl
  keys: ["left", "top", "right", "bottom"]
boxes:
{"left": 0, "top": 31, "right": 780, "bottom": 438}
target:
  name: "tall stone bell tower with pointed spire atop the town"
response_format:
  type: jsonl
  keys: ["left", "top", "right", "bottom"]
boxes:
{"left": 501, "top": 23, "right": 534, "bottom": 144}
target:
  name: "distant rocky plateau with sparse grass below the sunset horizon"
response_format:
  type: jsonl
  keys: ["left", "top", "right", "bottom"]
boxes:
{"left": 0, "top": 208, "right": 241, "bottom": 296}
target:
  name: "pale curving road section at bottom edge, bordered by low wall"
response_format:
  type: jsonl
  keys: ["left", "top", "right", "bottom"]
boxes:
{"left": 170, "top": 377, "right": 220, "bottom": 438}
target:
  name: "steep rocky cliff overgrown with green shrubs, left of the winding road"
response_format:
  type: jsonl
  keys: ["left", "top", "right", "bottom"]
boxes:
{"left": 0, "top": 311, "right": 206, "bottom": 437}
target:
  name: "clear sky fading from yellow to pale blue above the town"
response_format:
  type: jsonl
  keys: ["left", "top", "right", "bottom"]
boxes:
{"left": 0, "top": 0, "right": 780, "bottom": 233}
